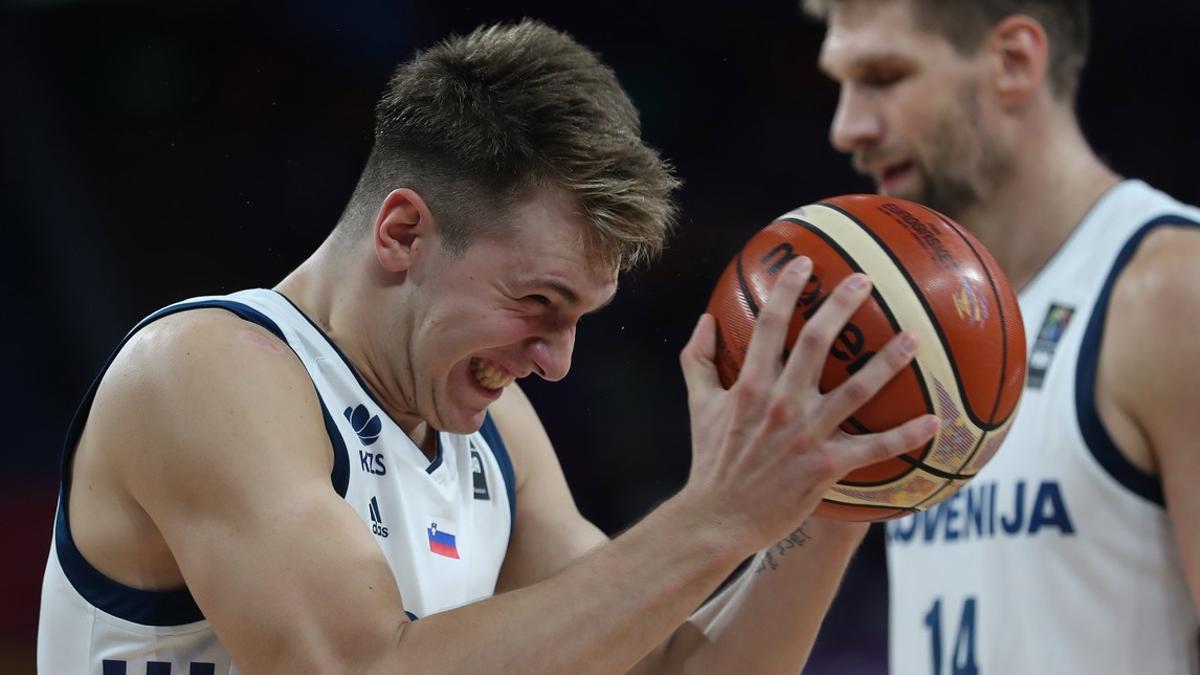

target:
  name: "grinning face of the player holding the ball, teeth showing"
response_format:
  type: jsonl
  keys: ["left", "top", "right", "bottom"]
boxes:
{"left": 397, "top": 189, "right": 617, "bottom": 434}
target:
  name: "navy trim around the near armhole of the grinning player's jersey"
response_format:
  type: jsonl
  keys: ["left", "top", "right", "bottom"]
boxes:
{"left": 54, "top": 299, "right": 350, "bottom": 626}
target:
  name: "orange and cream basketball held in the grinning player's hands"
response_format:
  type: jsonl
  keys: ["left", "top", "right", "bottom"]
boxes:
{"left": 708, "top": 195, "right": 1025, "bottom": 521}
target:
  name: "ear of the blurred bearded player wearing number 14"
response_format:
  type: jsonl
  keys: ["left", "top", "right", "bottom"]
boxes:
{"left": 988, "top": 14, "right": 1050, "bottom": 108}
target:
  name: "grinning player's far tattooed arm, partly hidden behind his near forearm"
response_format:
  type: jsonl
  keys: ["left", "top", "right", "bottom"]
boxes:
{"left": 492, "top": 260, "right": 931, "bottom": 674}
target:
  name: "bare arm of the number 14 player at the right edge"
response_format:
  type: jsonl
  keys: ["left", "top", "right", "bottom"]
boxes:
{"left": 1099, "top": 223, "right": 1200, "bottom": 609}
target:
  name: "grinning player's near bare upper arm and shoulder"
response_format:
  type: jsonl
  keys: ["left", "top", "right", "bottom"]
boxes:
{"left": 109, "top": 310, "right": 406, "bottom": 673}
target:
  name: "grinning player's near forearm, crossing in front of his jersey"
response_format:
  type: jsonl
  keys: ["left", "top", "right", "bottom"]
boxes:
{"left": 376, "top": 498, "right": 746, "bottom": 674}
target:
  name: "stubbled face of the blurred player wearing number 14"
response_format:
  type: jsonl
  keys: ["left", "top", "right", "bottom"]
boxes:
{"left": 821, "top": 0, "right": 1012, "bottom": 217}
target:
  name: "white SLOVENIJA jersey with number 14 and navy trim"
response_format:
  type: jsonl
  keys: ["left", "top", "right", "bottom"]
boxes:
{"left": 887, "top": 180, "right": 1200, "bottom": 675}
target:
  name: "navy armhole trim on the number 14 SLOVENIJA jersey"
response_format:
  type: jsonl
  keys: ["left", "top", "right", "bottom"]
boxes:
{"left": 1075, "top": 215, "right": 1200, "bottom": 506}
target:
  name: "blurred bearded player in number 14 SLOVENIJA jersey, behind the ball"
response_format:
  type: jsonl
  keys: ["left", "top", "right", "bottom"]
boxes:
{"left": 805, "top": 0, "right": 1200, "bottom": 675}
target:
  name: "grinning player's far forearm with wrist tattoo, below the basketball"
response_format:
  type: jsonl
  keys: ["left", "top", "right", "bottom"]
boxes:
{"left": 636, "top": 519, "right": 866, "bottom": 675}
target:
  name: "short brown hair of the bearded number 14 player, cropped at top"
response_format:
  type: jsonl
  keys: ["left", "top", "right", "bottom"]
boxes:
{"left": 802, "top": 0, "right": 1091, "bottom": 100}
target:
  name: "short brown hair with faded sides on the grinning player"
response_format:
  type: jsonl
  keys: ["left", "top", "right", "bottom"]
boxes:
{"left": 340, "top": 19, "right": 679, "bottom": 269}
